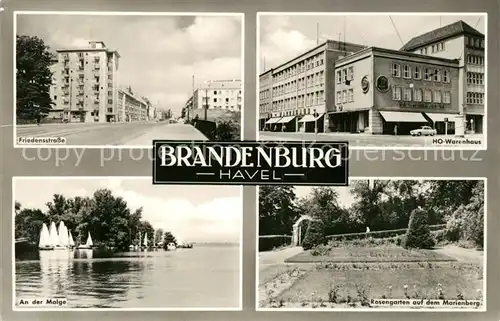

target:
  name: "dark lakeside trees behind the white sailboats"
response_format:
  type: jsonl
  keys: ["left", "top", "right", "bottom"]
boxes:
{"left": 15, "top": 189, "right": 177, "bottom": 251}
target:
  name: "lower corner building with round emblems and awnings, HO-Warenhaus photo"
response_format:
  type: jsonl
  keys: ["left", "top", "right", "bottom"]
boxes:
{"left": 334, "top": 47, "right": 459, "bottom": 134}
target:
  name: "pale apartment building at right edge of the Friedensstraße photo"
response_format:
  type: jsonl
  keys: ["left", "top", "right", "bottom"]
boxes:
{"left": 192, "top": 80, "right": 242, "bottom": 111}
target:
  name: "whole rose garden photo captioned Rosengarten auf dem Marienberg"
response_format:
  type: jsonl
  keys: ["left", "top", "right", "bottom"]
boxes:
{"left": 256, "top": 177, "right": 486, "bottom": 311}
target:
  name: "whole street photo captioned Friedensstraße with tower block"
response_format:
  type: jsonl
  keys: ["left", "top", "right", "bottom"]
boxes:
{"left": 13, "top": 11, "right": 244, "bottom": 148}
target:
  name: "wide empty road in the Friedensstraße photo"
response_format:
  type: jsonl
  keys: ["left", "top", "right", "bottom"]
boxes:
{"left": 16, "top": 122, "right": 207, "bottom": 146}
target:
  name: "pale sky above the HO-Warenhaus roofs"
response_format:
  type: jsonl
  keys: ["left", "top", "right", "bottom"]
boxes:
{"left": 259, "top": 15, "right": 486, "bottom": 72}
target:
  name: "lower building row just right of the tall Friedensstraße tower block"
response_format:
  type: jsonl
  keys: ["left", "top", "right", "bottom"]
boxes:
{"left": 116, "top": 86, "right": 149, "bottom": 122}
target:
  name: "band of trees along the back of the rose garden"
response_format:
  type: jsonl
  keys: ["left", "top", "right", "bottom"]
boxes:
{"left": 259, "top": 180, "right": 484, "bottom": 247}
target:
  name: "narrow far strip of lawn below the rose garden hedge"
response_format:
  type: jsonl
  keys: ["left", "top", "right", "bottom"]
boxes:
{"left": 286, "top": 245, "right": 455, "bottom": 263}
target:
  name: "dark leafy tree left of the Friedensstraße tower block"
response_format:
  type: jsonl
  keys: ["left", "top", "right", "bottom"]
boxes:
{"left": 16, "top": 35, "right": 54, "bottom": 119}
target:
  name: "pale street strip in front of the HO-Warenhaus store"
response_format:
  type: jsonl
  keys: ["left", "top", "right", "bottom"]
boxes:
{"left": 258, "top": 131, "right": 484, "bottom": 149}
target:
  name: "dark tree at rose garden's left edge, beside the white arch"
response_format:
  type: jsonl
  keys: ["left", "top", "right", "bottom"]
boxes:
{"left": 259, "top": 185, "right": 298, "bottom": 235}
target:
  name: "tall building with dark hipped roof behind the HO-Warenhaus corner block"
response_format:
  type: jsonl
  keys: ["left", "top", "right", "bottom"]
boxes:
{"left": 401, "top": 21, "right": 486, "bottom": 133}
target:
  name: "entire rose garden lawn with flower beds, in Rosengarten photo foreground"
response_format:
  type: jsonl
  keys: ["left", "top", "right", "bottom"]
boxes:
{"left": 259, "top": 245, "right": 483, "bottom": 308}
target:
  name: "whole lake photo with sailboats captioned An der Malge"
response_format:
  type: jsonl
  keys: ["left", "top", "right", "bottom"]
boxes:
{"left": 12, "top": 177, "right": 242, "bottom": 311}
